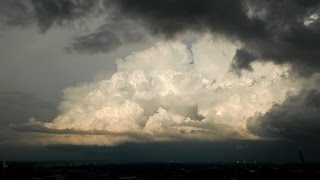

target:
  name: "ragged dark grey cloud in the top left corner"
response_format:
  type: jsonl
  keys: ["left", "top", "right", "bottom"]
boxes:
{"left": 1, "top": 0, "right": 98, "bottom": 32}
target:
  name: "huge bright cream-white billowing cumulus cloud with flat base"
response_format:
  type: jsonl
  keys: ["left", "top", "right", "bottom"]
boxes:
{"left": 24, "top": 36, "right": 300, "bottom": 145}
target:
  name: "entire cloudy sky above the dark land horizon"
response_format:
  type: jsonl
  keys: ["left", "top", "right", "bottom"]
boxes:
{"left": 0, "top": 0, "right": 320, "bottom": 163}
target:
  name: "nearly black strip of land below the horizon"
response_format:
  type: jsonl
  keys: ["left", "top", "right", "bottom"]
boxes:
{"left": 0, "top": 162, "right": 320, "bottom": 180}
